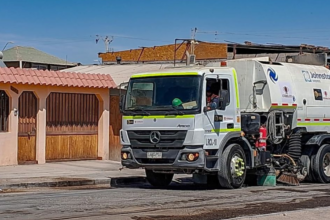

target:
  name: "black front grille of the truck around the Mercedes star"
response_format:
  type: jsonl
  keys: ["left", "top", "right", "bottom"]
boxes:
{"left": 127, "top": 130, "right": 187, "bottom": 149}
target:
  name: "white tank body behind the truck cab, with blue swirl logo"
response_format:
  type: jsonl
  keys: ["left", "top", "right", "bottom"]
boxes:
{"left": 209, "top": 57, "right": 330, "bottom": 132}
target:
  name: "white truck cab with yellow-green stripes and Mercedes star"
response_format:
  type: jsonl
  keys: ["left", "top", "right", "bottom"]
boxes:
{"left": 120, "top": 67, "right": 246, "bottom": 186}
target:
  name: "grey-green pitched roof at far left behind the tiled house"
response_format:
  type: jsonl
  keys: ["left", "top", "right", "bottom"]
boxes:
{"left": 3, "top": 46, "right": 77, "bottom": 66}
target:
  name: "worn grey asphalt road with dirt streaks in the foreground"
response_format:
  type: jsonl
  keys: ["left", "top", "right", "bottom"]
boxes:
{"left": 0, "top": 179, "right": 330, "bottom": 220}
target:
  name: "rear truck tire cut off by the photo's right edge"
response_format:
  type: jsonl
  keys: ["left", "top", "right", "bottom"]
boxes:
{"left": 311, "top": 144, "right": 330, "bottom": 183}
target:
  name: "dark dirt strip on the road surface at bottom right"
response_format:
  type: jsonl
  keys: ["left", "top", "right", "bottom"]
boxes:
{"left": 133, "top": 196, "right": 330, "bottom": 220}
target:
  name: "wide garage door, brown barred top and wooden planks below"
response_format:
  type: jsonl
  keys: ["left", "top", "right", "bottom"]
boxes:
{"left": 46, "top": 93, "right": 99, "bottom": 161}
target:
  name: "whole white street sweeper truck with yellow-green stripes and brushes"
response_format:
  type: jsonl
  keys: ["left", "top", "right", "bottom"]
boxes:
{"left": 120, "top": 58, "right": 330, "bottom": 188}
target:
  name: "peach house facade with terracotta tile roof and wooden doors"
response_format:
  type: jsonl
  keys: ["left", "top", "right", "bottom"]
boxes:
{"left": 0, "top": 67, "right": 115, "bottom": 165}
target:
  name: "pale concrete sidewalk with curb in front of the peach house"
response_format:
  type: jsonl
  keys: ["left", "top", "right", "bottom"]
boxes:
{"left": 0, "top": 160, "right": 145, "bottom": 189}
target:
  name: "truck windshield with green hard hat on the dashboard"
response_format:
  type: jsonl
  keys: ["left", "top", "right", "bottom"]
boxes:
{"left": 125, "top": 76, "right": 201, "bottom": 113}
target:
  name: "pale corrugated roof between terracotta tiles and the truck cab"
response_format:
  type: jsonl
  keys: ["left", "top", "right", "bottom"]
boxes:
{"left": 61, "top": 64, "right": 187, "bottom": 86}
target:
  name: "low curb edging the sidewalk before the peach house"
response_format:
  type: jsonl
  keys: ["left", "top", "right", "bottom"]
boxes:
{"left": 0, "top": 177, "right": 146, "bottom": 190}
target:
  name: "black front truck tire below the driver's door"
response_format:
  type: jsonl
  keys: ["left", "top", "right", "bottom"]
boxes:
{"left": 218, "top": 144, "right": 246, "bottom": 189}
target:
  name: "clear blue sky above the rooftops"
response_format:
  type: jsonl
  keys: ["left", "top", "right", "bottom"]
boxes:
{"left": 0, "top": 0, "right": 330, "bottom": 65}
